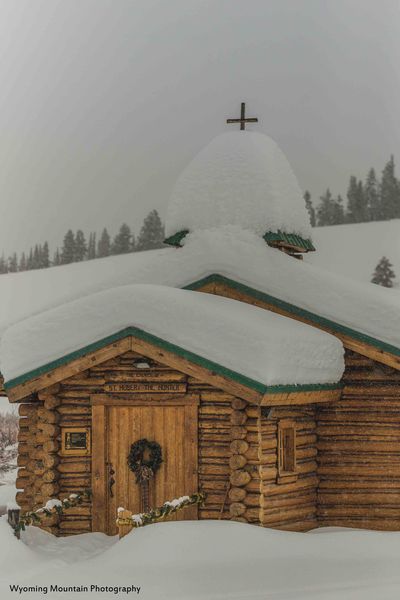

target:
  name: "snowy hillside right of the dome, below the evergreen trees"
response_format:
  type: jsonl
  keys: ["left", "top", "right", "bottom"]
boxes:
{"left": 305, "top": 219, "right": 400, "bottom": 288}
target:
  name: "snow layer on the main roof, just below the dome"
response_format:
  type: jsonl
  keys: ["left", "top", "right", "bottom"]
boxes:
{"left": 0, "top": 226, "right": 400, "bottom": 370}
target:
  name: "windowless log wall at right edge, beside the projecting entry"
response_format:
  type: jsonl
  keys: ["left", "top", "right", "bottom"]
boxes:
{"left": 317, "top": 351, "right": 400, "bottom": 530}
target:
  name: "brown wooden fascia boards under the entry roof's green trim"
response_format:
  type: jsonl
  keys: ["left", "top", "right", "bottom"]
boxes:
{"left": 6, "top": 327, "right": 341, "bottom": 405}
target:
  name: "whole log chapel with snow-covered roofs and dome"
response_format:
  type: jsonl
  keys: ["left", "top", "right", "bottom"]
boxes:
{"left": 0, "top": 110, "right": 400, "bottom": 535}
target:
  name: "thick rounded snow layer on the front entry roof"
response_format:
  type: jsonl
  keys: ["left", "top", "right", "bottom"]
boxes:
{"left": 0, "top": 285, "right": 344, "bottom": 385}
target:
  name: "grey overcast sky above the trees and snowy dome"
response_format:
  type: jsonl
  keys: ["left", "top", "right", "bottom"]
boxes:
{"left": 0, "top": 0, "right": 400, "bottom": 253}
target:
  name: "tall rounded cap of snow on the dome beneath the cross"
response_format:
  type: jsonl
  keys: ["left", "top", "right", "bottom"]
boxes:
{"left": 166, "top": 131, "right": 311, "bottom": 247}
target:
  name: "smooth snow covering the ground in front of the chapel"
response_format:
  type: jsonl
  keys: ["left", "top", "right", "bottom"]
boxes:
{"left": 0, "top": 518, "right": 400, "bottom": 600}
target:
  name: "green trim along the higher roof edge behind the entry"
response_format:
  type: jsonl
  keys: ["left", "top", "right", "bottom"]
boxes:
{"left": 185, "top": 273, "right": 400, "bottom": 356}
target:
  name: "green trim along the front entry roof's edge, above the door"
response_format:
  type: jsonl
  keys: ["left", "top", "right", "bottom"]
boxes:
{"left": 5, "top": 327, "right": 342, "bottom": 394}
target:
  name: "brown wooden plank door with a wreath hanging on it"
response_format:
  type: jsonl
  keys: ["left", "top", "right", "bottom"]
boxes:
{"left": 92, "top": 396, "right": 198, "bottom": 535}
